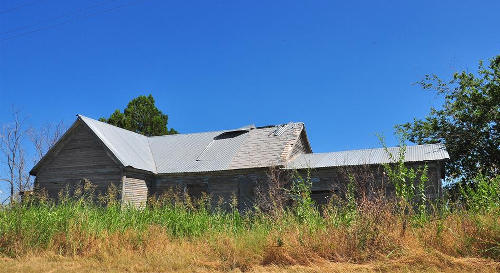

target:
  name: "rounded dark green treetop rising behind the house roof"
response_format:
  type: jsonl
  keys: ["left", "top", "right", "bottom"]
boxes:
{"left": 99, "top": 95, "right": 177, "bottom": 136}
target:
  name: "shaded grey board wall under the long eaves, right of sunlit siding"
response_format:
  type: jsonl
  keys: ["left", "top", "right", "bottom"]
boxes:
{"left": 150, "top": 162, "right": 441, "bottom": 210}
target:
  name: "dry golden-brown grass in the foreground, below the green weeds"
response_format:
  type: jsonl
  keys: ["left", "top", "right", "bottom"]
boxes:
{"left": 0, "top": 212, "right": 500, "bottom": 273}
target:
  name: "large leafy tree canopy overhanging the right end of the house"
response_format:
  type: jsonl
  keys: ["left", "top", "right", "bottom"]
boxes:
{"left": 396, "top": 55, "right": 500, "bottom": 180}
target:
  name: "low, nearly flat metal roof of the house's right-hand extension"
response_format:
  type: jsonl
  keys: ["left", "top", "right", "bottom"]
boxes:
{"left": 287, "top": 144, "right": 450, "bottom": 169}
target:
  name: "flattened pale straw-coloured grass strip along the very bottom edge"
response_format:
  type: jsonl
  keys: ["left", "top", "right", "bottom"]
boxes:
{"left": 0, "top": 252, "right": 500, "bottom": 273}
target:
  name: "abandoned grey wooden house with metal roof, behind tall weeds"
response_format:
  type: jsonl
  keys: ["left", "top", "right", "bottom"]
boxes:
{"left": 30, "top": 115, "right": 449, "bottom": 209}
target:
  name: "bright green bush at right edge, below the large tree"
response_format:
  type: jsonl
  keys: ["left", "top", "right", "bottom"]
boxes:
{"left": 460, "top": 174, "right": 500, "bottom": 212}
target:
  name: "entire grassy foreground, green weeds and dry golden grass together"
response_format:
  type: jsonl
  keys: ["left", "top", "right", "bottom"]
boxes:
{"left": 0, "top": 189, "right": 500, "bottom": 272}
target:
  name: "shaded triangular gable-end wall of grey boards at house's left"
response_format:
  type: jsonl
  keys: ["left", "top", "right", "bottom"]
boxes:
{"left": 35, "top": 124, "right": 121, "bottom": 198}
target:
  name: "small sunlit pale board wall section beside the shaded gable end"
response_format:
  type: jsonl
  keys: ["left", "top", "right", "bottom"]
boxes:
{"left": 122, "top": 171, "right": 150, "bottom": 208}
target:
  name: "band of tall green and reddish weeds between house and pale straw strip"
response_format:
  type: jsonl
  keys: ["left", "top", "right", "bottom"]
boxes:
{"left": 0, "top": 168, "right": 500, "bottom": 264}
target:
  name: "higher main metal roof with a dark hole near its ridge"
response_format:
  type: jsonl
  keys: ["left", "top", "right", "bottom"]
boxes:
{"left": 79, "top": 115, "right": 302, "bottom": 173}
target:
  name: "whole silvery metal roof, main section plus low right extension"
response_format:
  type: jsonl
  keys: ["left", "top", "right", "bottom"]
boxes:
{"left": 72, "top": 115, "right": 449, "bottom": 173}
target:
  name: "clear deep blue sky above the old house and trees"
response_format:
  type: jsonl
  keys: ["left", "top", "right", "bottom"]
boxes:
{"left": 0, "top": 0, "right": 500, "bottom": 198}
